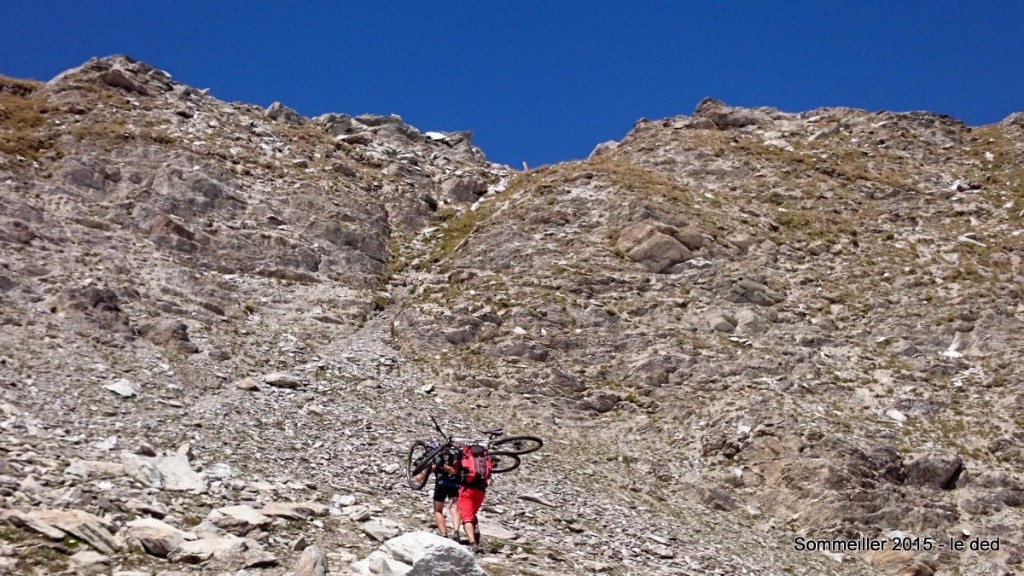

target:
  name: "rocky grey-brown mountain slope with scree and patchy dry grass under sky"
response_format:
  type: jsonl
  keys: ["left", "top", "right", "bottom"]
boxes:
{"left": 0, "top": 56, "right": 1024, "bottom": 574}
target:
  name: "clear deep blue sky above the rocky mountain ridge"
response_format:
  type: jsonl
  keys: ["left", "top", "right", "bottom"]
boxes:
{"left": 0, "top": 0, "right": 1024, "bottom": 167}
